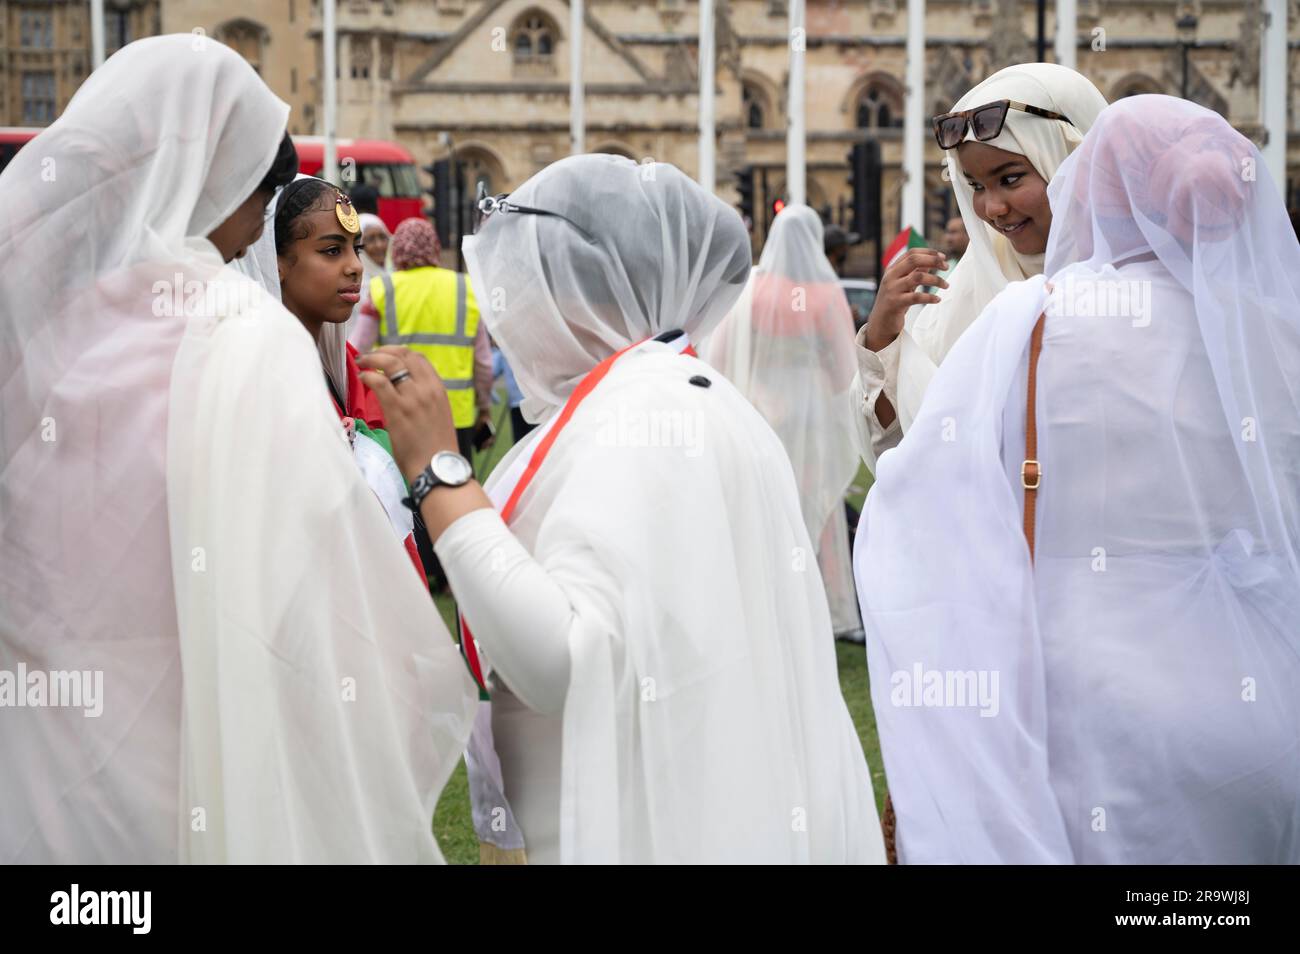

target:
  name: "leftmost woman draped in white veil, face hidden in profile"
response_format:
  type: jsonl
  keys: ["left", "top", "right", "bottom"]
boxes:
{"left": 0, "top": 34, "right": 473, "bottom": 863}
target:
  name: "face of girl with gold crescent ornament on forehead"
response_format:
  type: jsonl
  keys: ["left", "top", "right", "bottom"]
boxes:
{"left": 278, "top": 204, "right": 361, "bottom": 334}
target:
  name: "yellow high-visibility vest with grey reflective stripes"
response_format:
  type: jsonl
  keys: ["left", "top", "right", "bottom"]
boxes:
{"left": 371, "top": 265, "right": 478, "bottom": 428}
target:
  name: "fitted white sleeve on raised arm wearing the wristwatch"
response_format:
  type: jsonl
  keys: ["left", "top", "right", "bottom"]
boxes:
{"left": 433, "top": 508, "right": 576, "bottom": 714}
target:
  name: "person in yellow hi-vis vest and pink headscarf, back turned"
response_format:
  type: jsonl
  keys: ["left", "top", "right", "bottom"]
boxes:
{"left": 364, "top": 218, "right": 491, "bottom": 458}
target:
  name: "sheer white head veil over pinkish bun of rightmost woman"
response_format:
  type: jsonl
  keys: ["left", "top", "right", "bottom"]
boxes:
{"left": 1047, "top": 96, "right": 1300, "bottom": 567}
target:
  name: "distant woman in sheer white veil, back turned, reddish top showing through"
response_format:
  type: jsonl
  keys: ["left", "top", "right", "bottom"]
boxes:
{"left": 703, "top": 205, "right": 862, "bottom": 639}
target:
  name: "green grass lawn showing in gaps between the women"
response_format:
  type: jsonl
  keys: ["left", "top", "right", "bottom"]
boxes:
{"left": 433, "top": 392, "right": 885, "bottom": 864}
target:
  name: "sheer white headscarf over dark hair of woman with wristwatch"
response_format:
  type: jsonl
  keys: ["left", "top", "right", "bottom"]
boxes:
{"left": 464, "top": 155, "right": 750, "bottom": 420}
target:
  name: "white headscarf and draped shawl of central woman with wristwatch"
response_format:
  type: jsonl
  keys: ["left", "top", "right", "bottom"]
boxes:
{"left": 465, "top": 156, "right": 883, "bottom": 862}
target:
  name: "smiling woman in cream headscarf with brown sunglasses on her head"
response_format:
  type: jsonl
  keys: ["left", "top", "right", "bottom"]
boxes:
{"left": 849, "top": 62, "right": 1106, "bottom": 471}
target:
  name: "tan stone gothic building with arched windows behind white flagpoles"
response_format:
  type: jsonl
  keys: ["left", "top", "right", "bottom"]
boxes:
{"left": 0, "top": 0, "right": 1300, "bottom": 265}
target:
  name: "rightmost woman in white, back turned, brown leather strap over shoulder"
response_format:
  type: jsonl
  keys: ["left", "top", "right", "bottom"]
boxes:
{"left": 855, "top": 96, "right": 1300, "bottom": 863}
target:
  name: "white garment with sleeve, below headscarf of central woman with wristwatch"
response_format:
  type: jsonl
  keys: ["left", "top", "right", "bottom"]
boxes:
{"left": 436, "top": 343, "right": 883, "bottom": 862}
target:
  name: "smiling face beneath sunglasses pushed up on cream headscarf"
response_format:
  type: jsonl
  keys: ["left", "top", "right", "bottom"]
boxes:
{"left": 957, "top": 142, "right": 1052, "bottom": 255}
